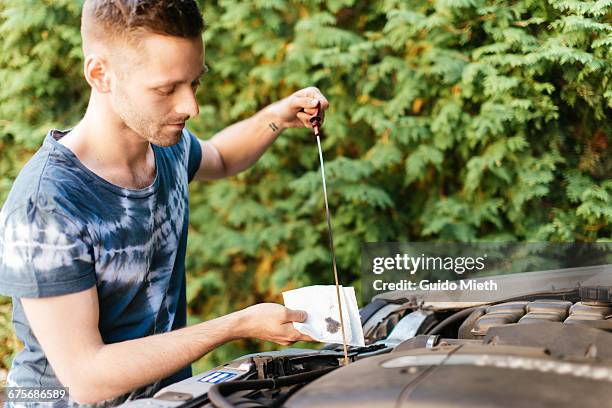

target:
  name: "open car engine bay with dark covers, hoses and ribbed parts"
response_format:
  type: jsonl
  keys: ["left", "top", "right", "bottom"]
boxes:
{"left": 120, "top": 270, "right": 612, "bottom": 408}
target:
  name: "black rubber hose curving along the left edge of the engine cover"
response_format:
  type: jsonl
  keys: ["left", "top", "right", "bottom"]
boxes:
{"left": 208, "top": 367, "right": 338, "bottom": 408}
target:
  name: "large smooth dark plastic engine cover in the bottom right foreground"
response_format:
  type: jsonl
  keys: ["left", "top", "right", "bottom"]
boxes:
{"left": 285, "top": 344, "right": 612, "bottom": 408}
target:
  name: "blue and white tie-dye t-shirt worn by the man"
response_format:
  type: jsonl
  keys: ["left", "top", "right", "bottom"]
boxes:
{"left": 0, "top": 130, "right": 202, "bottom": 405}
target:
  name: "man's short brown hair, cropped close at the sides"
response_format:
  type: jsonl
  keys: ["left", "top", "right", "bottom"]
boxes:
{"left": 81, "top": 0, "right": 205, "bottom": 52}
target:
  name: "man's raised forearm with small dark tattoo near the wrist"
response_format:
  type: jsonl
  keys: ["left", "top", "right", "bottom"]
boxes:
{"left": 210, "top": 107, "right": 284, "bottom": 176}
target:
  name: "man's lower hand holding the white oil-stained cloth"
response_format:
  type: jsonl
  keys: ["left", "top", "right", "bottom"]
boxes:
{"left": 239, "top": 303, "right": 314, "bottom": 346}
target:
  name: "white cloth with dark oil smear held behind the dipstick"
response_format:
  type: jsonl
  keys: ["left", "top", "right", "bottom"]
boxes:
{"left": 283, "top": 285, "right": 365, "bottom": 347}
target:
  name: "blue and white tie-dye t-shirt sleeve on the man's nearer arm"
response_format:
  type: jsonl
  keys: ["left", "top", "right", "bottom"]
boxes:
{"left": 0, "top": 202, "right": 96, "bottom": 298}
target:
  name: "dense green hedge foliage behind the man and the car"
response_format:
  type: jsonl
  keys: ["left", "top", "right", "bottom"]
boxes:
{"left": 0, "top": 0, "right": 612, "bottom": 374}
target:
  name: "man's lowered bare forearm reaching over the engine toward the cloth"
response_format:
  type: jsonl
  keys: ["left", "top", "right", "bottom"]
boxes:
{"left": 70, "top": 312, "right": 242, "bottom": 403}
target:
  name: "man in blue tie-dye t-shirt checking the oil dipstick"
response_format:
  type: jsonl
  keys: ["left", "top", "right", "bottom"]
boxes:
{"left": 0, "top": 0, "right": 328, "bottom": 406}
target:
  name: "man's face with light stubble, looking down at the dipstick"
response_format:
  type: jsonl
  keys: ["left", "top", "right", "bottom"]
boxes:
{"left": 111, "top": 33, "right": 204, "bottom": 146}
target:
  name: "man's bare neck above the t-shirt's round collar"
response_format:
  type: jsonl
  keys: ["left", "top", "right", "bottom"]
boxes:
{"left": 59, "top": 100, "right": 155, "bottom": 189}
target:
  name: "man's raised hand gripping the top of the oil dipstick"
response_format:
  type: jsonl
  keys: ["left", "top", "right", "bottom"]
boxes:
{"left": 266, "top": 86, "right": 329, "bottom": 129}
